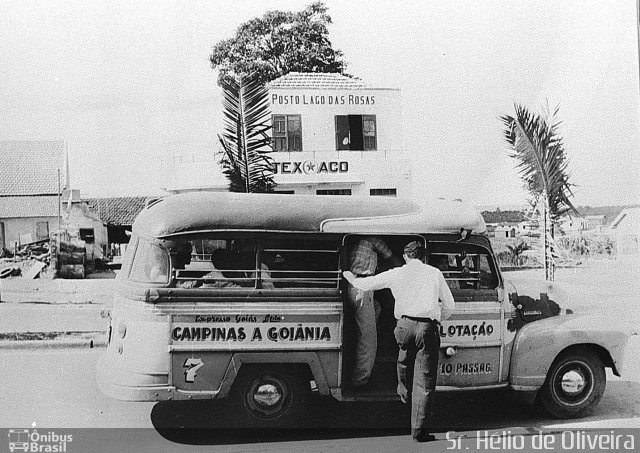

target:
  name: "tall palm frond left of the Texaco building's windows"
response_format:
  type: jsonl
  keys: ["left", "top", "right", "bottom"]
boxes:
{"left": 218, "top": 75, "right": 276, "bottom": 193}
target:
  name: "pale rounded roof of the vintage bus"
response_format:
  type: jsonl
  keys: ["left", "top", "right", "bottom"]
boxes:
{"left": 133, "top": 192, "right": 486, "bottom": 238}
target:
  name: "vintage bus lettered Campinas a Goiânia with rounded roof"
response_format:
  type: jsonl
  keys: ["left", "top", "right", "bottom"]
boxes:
{"left": 98, "top": 192, "right": 627, "bottom": 426}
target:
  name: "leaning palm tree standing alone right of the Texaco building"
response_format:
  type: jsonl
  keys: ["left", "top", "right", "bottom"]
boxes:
{"left": 500, "top": 104, "right": 577, "bottom": 281}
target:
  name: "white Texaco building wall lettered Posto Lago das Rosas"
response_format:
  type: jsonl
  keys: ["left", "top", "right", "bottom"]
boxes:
{"left": 270, "top": 88, "right": 411, "bottom": 196}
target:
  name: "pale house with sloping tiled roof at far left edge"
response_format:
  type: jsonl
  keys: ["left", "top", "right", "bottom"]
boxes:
{"left": 0, "top": 141, "right": 69, "bottom": 248}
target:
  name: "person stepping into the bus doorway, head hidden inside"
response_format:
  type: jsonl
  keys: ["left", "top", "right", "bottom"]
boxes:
{"left": 347, "top": 236, "right": 403, "bottom": 387}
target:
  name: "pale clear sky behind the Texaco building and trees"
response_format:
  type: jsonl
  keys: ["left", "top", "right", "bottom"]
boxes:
{"left": 0, "top": 0, "right": 640, "bottom": 207}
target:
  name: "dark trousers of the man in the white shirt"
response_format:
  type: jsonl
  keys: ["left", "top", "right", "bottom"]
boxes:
{"left": 394, "top": 316, "right": 440, "bottom": 438}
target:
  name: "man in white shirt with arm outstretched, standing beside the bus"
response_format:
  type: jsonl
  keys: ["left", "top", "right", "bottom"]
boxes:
{"left": 344, "top": 241, "right": 455, "bottom": 442}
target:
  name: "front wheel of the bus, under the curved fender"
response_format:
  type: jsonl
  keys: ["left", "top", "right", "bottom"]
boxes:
{"left": 539, "top": 349, "right": 606, "bottom": 418}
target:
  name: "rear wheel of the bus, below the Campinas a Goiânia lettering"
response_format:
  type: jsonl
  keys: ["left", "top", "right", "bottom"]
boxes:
{"left": 233, "top": 365, "right": 311, "bottom": 428}
